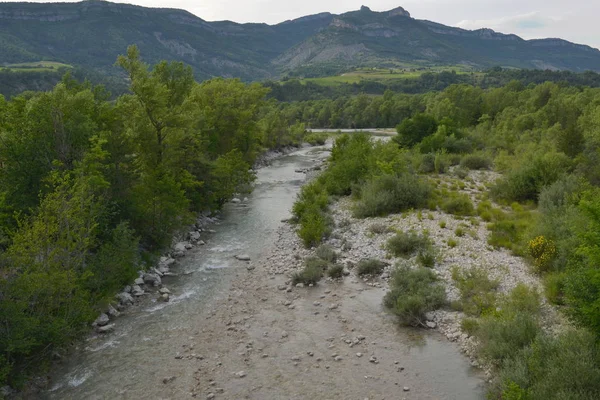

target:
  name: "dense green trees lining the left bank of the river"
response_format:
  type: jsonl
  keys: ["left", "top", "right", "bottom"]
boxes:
{"left": 0, "top": 47, "right": 304, "bottom": 386}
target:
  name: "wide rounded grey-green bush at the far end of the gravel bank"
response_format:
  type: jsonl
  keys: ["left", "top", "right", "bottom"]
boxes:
{"left": 354, "top": 174, "right": 431, "bottom": 218}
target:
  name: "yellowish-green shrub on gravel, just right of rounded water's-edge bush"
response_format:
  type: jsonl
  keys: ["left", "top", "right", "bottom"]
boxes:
{"left": 452, "top": 267, "right": 499, "bottom": 316}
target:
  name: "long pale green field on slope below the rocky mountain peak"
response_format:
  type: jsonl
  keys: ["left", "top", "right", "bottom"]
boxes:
{"left": 301, "top": 66, "right": 481, "bottom": 86}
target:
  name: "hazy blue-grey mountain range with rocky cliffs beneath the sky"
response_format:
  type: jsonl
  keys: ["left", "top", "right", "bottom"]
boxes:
{"left": 0, "top": 0, "right": 600, "bottom": 80}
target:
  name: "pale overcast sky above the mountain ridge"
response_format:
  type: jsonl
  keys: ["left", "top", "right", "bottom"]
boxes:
{"left": 8, "top": 0, "right": 600, "bottom": 48}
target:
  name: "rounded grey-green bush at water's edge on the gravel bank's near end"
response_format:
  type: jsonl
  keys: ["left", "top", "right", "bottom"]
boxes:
{"left": 384, "top": 266, "right": 446, "bottom": 326}
